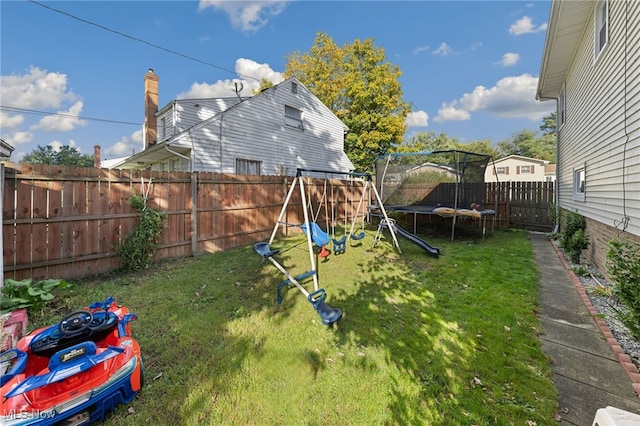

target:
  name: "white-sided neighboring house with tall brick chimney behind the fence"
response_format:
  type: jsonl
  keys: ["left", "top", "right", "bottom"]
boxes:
{"left": 106, "top": 70, "right": 354, "bottom": 175}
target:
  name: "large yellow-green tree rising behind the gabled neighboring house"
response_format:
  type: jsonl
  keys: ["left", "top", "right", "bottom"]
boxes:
{"left": 284, "top": 32, "right": 411, "bottom": 171}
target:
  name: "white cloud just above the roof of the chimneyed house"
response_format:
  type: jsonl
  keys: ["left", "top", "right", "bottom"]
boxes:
{"left": 176, "top": 58, "right": 284, "bottom": 99}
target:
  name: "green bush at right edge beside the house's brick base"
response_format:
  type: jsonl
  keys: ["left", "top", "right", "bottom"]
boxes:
{"left": 607, "top": 239, "right": 640, "bottom": 324}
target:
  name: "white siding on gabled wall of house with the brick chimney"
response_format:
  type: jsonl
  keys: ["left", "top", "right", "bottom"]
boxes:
{"left": 159, "top": 80, "right": 353, "bottom": 175}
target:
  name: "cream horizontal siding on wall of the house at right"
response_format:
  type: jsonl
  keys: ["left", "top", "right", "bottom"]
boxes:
{"left": 558, "top": 1, "right": 640, "bottom": 235}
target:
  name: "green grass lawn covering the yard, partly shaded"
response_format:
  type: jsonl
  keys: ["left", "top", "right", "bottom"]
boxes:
{"left": 31, "top": 226, "right": 557, "bottom": 425}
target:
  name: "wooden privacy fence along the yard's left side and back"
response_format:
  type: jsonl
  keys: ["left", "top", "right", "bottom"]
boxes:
{"left": 2, "top": 164, "right": 553, "bottom": 280}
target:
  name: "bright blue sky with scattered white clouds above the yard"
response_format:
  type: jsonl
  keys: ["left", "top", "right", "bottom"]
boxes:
{"left": 0, "top": 0, "right": 555, "bottom": 161}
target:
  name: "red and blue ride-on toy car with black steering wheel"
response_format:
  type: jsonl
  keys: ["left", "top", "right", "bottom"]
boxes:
{"left": 0, "top": 298, "right": 143, "bottom": 426}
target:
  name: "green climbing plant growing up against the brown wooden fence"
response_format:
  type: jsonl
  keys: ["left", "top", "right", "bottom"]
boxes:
{"left": 116, "top": 195, "right": 167, "bottom": 271}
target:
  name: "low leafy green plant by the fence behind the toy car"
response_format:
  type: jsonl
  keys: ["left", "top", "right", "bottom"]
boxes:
{"left": 0, "top": 278, "right": 71, "bottom": 313}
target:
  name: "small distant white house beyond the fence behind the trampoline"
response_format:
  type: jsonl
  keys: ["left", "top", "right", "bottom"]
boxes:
{"left": 484, "top": 155, "right": 549, "bottom": 182}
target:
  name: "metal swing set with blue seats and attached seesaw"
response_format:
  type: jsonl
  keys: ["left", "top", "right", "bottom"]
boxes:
{"left": 253, "top": 168, "right": 400, "bottom": 326}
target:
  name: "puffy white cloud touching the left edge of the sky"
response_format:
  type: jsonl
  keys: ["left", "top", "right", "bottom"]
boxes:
{"left": 0, "top": 67, "right": 77, "bottom": 109}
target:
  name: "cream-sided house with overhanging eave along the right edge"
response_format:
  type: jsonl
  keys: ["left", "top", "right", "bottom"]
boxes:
{"left": 536, "top": 0, "right": 640, "bottom": 271}
